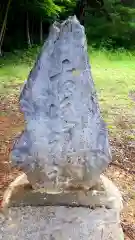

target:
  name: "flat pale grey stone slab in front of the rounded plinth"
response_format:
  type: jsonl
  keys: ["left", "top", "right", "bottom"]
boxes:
{"left": 0, "top": 206, "right": 124, "bottom": 240}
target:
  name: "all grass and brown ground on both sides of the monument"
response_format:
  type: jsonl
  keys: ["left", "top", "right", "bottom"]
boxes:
{"left": 0, "top": 47, "right": 135, "bottom": 239}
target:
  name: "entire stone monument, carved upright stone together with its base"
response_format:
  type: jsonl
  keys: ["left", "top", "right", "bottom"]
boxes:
{"left": 0, "top": 16, "right": 124, "bottom": 240}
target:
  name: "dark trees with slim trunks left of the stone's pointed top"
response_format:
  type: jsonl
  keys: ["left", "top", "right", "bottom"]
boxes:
{"left": 0, "top": 0, "right": 76, "bottom": 51}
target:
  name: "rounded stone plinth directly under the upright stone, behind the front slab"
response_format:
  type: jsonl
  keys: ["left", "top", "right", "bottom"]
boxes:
{"left": 3, "top": 174, "right": 123, "bottom": 212}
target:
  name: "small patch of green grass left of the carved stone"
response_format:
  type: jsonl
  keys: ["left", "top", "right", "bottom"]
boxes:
{"left": 0, "top": 47, "right": 39, "bottom": 95}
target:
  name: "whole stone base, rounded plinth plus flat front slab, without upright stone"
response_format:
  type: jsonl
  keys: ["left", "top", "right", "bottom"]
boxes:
{"left": 0, "top": 174, "right": 124, "bottom": 240}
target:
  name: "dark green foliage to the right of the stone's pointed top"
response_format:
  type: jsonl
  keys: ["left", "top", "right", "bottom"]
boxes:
{"left": 85, "top": 0, "right": 135, "bottom": 48}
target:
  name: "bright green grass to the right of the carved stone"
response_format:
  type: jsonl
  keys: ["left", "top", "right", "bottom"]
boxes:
{"left": 89, "top": 50, "right": 135, "bottom": 138}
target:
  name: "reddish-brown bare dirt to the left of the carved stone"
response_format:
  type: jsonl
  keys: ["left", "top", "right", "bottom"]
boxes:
{"left": 0, "top": 98, "right": 24, "bottom": 199}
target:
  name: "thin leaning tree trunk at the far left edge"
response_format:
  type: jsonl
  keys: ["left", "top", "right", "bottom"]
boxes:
{"left": 0, "top": 0, "right": 11, "bottom": 56}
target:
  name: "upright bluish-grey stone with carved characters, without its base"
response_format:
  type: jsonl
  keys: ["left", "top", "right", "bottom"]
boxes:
{"left": 11, "top": 17, "right": 111, "bottom": 192}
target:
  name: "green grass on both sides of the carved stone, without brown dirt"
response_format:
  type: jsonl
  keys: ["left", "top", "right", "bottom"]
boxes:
{"left": 0, "top": 47, "right": 135, "bottom": 138}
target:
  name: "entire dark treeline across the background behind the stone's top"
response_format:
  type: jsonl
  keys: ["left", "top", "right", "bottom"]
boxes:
{"left": 0, "top": 0, "right": 135, "bottom": 54}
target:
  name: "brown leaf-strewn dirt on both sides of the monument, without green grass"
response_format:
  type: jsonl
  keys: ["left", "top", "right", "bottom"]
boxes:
{"left": 0, "top": 96, "right": 135, "bottom": 240}
